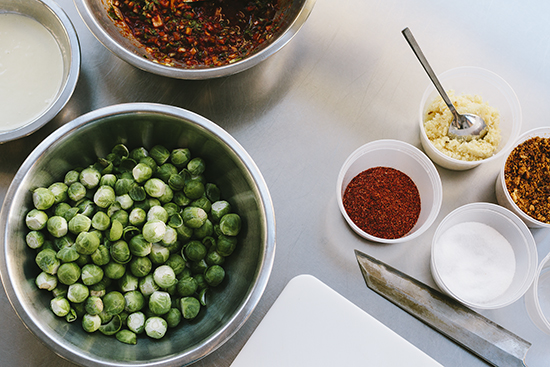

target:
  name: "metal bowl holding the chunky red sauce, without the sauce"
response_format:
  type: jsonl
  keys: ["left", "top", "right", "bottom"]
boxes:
{"left": 74, "top": 0, "right": 315, "bottom": 79}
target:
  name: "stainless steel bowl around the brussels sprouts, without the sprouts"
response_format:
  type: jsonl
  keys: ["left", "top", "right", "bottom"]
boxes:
{"left": 0, "top": 103, "right": 275, "bottom": 367}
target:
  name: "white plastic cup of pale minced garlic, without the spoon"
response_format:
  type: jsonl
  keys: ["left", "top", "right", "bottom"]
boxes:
{"left": 419, "top": 67, "right": 521, "bottom": 170}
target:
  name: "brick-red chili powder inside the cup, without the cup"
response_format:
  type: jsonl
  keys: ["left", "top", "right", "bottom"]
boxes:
{"left": 343, "top": 167, "right": 420, "bottom": 239}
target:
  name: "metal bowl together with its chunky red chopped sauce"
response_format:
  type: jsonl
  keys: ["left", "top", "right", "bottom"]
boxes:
{"left": 74, "top": 0, "right": 315, "bottom": 79}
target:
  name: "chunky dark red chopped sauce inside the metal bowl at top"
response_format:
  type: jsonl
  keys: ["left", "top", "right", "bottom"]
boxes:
{"left": 109, "top": 0, "right": 280, "bottom": 67}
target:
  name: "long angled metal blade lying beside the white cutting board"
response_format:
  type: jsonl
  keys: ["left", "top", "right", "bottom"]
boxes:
{"left": 355, "top": 250, "right": 531, "bottom": 367}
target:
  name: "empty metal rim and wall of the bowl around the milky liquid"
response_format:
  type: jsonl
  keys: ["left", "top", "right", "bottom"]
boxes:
{"left": 0, "top": 0, "right": 80, "bottom": 143}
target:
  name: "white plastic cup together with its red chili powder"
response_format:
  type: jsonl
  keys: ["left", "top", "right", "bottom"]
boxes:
{"left": 337, "top": 139, "right": 443, "bottom": 243}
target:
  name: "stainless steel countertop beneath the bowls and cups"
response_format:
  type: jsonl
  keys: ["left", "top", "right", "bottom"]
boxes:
{"left": 0, "top": 0, "right": 550, "bottom": 367}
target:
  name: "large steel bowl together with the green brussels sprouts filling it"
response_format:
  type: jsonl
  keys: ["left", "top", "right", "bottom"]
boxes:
{"left": 0, "top": 103, "right": 275, "bottom": 366}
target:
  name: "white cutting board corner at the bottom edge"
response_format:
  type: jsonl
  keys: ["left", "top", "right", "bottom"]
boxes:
{"left": 231, "top": 275, "right": 442, "bottom": 367}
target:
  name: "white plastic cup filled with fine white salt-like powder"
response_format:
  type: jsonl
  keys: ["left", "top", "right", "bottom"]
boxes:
{"left": 431, "top": 203, "right": 538, "bottom": 309}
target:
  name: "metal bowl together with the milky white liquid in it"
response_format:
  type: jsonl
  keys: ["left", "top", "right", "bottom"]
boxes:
{"left": 0, "top": 0, "right": 80, "bottom": 143}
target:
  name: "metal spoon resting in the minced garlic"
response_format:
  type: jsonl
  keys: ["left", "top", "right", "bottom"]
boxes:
{"left": 401, "top": 28, "right": 487, "bottom": 141}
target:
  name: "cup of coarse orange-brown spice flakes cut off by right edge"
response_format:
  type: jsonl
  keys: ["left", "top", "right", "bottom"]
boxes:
{"left": 495, "top": 127, "right": 550, "bottom": 228}
